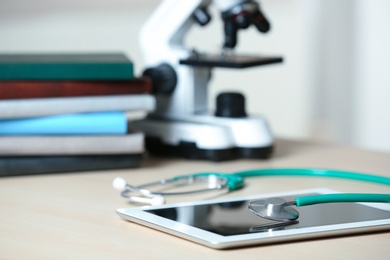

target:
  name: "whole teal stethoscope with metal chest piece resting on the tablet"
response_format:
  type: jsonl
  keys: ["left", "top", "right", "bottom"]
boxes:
{"left": 113, "top": 168, "right": 390, "bottom": 222}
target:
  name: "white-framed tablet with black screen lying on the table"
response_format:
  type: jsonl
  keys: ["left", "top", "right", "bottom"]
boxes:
{"left": 117, "top": 189, "right": 390, "bottom": 249}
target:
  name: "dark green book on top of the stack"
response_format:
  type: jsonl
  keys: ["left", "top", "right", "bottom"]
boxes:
{"left": 0, "top": 53, "right": 134, "bottom": 80}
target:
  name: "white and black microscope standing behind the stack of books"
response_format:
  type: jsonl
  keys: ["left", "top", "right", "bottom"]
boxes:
{"left": 134, "top": 0, "right": 282, "bottom": 161}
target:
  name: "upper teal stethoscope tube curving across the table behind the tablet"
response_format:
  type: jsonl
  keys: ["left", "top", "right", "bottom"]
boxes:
{"left": 234, "top": 168, "right": 390, "bottom": 185}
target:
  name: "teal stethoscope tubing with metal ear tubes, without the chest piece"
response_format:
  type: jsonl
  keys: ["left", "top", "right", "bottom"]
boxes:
{"left": 116, "top": 168, "right": 390, "bottom": 207}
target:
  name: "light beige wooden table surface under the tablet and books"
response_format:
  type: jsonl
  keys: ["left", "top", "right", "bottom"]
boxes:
{"left": 0, "top": 140, "right": 390, "bottom": 260}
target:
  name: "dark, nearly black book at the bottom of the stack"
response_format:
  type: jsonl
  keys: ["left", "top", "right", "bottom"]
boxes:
{"left": 0, "top": 154, "right": 142, "bottom": 177}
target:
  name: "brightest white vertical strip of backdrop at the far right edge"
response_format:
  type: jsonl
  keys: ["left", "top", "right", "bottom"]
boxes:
{"left": 352, "top": 0, "right": 390, "bottom": 151}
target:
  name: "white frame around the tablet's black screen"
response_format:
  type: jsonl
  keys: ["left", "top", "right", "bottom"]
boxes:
{"left": 116, "top": 188, "right": 390, "bottom": 249}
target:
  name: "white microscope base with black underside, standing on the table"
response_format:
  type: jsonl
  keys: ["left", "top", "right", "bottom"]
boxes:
{"left": 133, "top": 115, "right": 273, "bottom": 161}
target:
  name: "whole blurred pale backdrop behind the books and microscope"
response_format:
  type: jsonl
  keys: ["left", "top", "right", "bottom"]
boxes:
{"left": 0, "top": 0, "right": 390, "bottom": 152}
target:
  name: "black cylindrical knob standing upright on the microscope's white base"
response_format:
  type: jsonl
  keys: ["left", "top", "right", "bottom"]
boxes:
{"left": 215, "top": 92, "right": 247, "bottom": 117}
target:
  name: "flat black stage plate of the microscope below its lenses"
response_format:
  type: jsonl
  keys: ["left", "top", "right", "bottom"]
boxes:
{"left": 180, "top": 54, "right": 283, "bottom": 69}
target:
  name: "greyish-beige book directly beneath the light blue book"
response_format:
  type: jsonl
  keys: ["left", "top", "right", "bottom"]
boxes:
{"left": 0, "top": 132, "right": 144, "bottom": 157}
